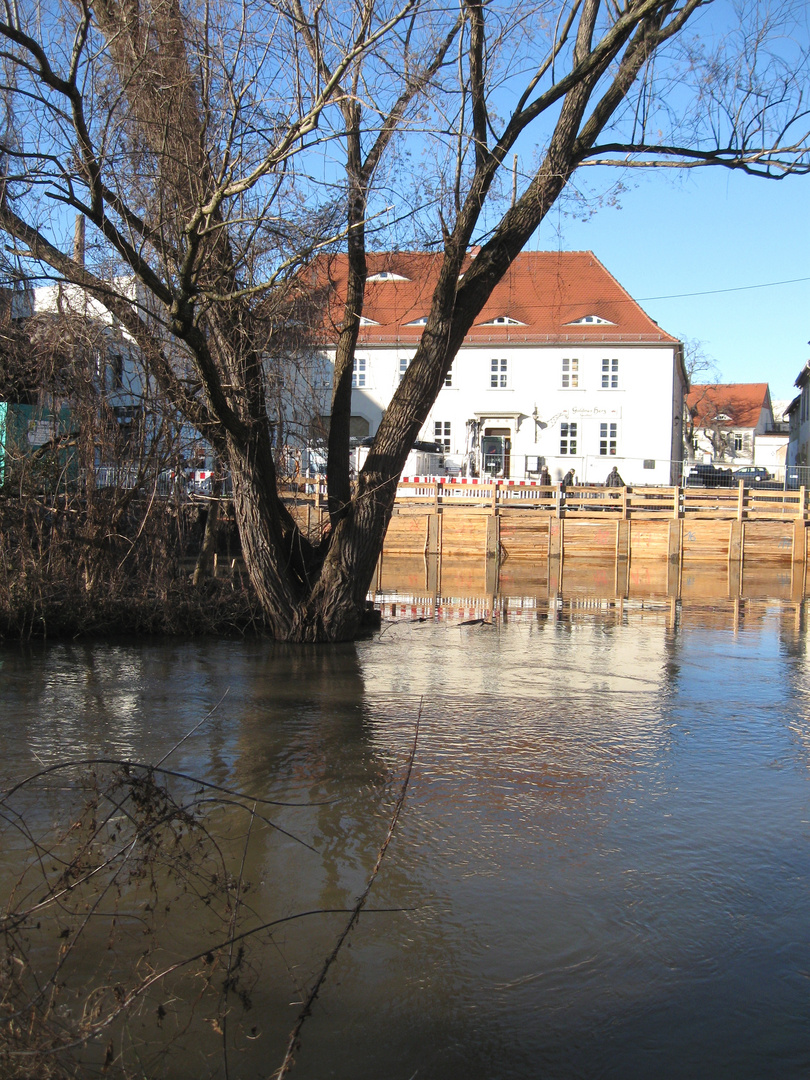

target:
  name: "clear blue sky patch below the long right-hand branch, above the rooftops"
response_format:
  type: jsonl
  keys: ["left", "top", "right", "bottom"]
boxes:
{"left": 531, "top": 168, "right": 810, "bottom": 408}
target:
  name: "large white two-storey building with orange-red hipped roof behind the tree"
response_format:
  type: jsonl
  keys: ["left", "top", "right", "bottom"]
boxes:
{"left": 313, "top": 252, "right": 687, "bottom": 484}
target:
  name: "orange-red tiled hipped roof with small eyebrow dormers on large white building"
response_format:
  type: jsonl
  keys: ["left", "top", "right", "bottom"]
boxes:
{"left": 313, "top": 252, "right": 677, "bottom": 345}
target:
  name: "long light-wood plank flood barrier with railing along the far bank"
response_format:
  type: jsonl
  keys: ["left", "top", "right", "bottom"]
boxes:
{"left": 282, "top": 480, "right": 808, "bottom": 566}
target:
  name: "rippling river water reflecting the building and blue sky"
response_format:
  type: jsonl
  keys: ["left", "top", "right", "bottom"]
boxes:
{"left": 0, "top": 570, "right": 810, "bottom": 1080}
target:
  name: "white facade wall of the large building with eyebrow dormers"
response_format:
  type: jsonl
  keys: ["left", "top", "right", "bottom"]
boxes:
{"left": 336, "top": 343, "right": 679, "bottom": 484}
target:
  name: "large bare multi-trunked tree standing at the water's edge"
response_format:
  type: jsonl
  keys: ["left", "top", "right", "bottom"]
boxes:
{"left": 0, "top": 0, "right": 810, "bottom": 640}
